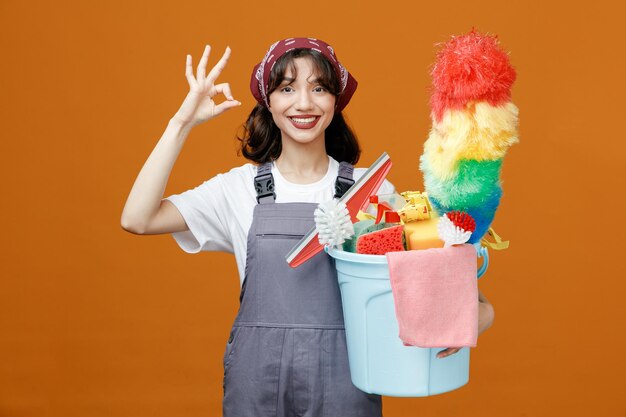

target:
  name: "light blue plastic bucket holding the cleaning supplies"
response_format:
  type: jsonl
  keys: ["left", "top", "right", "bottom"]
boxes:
{"left": 325, "top": 246, "right": 468, "bottom": 397}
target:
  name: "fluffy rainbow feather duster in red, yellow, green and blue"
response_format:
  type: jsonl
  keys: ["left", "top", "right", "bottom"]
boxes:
{"left": 420, "top": 30, "right": 518, "bottom": 243}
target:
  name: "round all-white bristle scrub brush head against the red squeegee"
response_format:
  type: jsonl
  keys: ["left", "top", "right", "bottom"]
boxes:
{"left": 314, "top": 199, "right": 354, "bottom": 247}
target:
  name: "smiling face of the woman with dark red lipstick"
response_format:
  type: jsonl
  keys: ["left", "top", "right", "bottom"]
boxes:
{"left": 269, "top": 57, "right": 335, "bottom": 148}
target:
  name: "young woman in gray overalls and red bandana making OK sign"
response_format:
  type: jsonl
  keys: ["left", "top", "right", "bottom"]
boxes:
{"left": 122, "top": 38, "right": 493, "bottom": 417}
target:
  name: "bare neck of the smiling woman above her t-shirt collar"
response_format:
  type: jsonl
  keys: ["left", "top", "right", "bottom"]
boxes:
{"left": 275, "top": 140, "right": 328, "bottom": 184}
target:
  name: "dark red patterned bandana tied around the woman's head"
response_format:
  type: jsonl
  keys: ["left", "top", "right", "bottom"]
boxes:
{"left": 250, "top": 38, "right": 357, "bottom": 113}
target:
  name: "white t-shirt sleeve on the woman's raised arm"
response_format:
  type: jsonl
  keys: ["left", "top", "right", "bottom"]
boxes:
{"left": 165, "top": 176, "right": 233, "bottom": 253}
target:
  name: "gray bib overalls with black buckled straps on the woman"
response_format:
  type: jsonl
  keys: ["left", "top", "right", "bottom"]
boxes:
{"left": 222, "top": 162, "right": 382, "bottom": 417}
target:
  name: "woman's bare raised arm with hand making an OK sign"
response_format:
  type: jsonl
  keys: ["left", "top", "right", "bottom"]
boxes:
{"left": 121, "top": 45, "right": 241, "bottom": 234}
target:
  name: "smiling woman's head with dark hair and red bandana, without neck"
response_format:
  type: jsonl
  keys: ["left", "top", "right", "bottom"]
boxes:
{"left": 239, "top": 46, "right": 361, "bottom": 165}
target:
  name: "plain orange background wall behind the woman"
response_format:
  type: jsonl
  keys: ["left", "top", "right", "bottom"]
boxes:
{"left": 0, "top": 0, "right": 626, "bottom": 417}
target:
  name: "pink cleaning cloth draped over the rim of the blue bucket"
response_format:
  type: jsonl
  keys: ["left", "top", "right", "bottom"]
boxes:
{"left": 387, "top": 244, "right": 478, "bottom": 348}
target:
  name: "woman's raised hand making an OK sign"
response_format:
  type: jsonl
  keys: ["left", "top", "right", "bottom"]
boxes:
{"left": 174, "top": 45, "right": 241, "bottom": 126}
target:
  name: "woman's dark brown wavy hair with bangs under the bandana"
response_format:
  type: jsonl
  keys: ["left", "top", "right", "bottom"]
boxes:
{"left": 237, "top": 48, "right": 361, "bottom": 165}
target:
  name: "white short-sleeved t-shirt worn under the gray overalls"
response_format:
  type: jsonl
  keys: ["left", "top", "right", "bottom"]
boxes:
{"left": 166, "top": 156, "right": 395, "bottom": 285}
